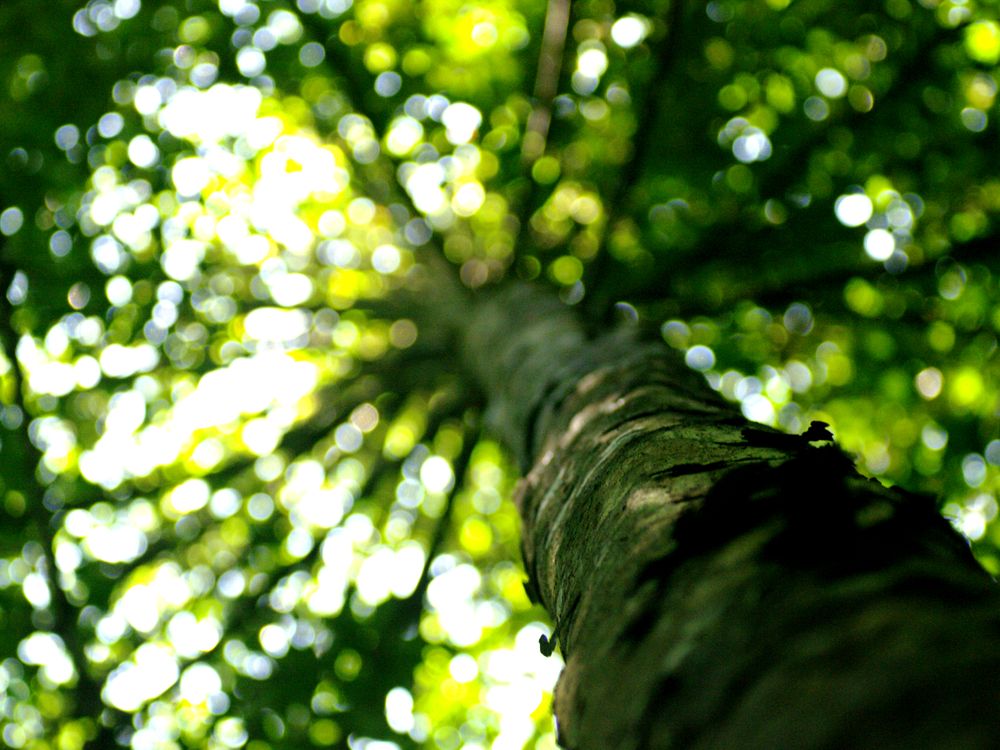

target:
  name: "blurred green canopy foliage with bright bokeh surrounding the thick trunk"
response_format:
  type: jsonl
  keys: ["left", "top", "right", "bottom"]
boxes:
{"left": 0, "top": 0, "right": 1000, "bottom": 750}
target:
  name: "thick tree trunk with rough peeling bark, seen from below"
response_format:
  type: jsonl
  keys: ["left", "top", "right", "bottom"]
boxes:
{"left": 464, "top": 287, "right": 1000, "bottom": 750}
